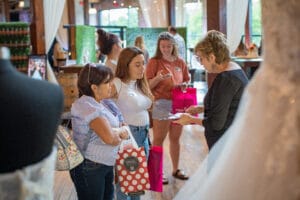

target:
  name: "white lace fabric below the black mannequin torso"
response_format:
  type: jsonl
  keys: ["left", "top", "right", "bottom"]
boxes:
{"left": 0, "top": 148, "right": 56, "bottom": 200}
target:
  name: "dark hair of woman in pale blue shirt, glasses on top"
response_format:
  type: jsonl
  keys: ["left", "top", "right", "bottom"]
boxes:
{"left": 77, "top": 63, "right": 113, "bottom": 97}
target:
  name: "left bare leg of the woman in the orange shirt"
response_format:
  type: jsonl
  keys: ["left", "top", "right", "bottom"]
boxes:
{"left": 169, "top": 124, "right": 182, "bottom": 173}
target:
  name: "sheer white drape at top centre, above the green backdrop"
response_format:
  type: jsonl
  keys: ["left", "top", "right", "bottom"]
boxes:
{"left": 139, "top": 0, "right": 169, "bottom": 27}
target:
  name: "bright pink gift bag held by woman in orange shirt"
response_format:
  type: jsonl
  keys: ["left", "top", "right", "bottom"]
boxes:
{"left": 172, "top": 88, "right": 197, "bottom": 114}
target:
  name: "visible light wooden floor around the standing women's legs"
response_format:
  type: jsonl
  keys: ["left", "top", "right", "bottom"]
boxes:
{"left": 54, "top": 125, "right": 208, "bottom": 200}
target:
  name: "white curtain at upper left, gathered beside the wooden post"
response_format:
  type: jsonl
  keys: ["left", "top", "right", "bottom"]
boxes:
{"left": 44, "top": 0, "right": 65, "bottom": 83}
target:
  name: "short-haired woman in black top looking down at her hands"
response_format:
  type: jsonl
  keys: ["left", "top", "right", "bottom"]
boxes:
{"left": 175, "top": 30, "right": 248, "bottom": 149}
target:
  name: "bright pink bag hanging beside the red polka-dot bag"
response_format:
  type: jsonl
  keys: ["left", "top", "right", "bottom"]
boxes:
{"left": 148, "top": 146, "right": 163, "bottom": 192}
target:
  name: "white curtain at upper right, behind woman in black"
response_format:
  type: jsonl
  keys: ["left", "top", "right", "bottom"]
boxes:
{"left": 227, "top": 0, "right": 248, "bottom": 53}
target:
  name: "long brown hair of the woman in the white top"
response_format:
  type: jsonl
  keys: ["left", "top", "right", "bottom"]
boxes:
{"left": 115, "top": 47, "right": 152, "bottom": 99}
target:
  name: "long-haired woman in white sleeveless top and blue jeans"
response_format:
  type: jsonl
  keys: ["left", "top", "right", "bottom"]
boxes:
{"left": 112, "top": 47, "right": 152, "bottom": 200}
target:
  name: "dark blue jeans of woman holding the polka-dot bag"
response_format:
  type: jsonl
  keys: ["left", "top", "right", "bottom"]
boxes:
{"left": 70, "top": 159, "right": 114, "bottom": 200}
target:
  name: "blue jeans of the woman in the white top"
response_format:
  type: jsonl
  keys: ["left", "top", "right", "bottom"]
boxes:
{"left": 116, "top": 125, "right": 149, "bottom": 200}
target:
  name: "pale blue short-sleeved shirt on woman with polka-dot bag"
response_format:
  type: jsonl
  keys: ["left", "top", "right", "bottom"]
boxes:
{"left": 71, "top": 95, "right": 120, "bottom": 166}
